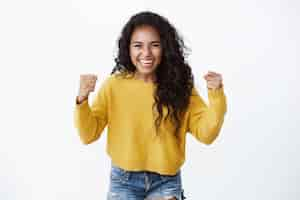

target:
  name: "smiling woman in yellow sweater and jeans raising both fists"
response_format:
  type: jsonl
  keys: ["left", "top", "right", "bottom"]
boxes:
{"left": 75, "top": 12, "right": 226, "bottom": 200}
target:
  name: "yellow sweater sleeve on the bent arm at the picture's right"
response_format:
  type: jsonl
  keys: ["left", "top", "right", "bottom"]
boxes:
{"left": 188, "top": 86, "right": 227, "bottom": 145}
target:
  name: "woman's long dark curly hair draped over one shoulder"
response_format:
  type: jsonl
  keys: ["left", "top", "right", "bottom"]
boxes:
{"left": 111, "top": 11, "right": 194, "bottom": 137}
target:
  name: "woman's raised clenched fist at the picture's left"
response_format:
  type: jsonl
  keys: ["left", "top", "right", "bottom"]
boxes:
{"left": 77, "top": 74, "right": 97, "bottom": 103}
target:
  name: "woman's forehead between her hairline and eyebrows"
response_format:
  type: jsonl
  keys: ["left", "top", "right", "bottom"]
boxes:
{"left": 131, "top": 25, "right": 160, "bottom": 41}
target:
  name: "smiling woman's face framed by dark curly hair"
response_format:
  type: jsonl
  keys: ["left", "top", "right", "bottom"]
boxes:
{"left": 129, "top": 26, "right": 162, "bottom": 75}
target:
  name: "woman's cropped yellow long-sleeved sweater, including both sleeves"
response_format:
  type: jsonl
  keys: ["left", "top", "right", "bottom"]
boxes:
{"left": 74, "top": 75, "right": 226, "bottom": 175}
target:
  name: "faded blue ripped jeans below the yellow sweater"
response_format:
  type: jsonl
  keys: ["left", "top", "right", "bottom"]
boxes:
{"left": 107, "top": 164, "right": 185, "bottom": 200}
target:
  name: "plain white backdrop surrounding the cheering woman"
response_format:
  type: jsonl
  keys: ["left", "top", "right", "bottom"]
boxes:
{"left": 0, "top": 0, "right": 300, "bottom": 200}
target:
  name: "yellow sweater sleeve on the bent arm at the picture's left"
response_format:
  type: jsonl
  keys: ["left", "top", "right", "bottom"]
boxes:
{"left": 74, "top": 79, "right": 109, "bottom": 144}
